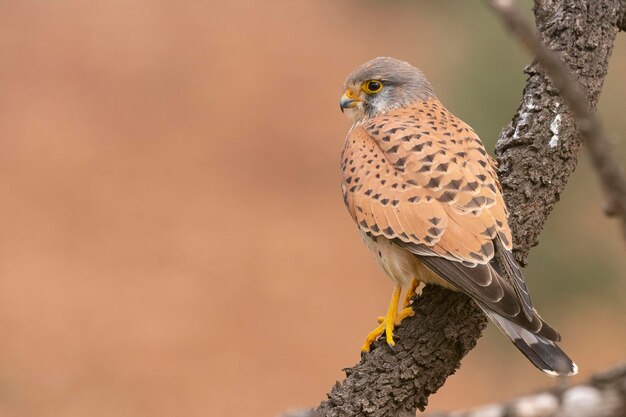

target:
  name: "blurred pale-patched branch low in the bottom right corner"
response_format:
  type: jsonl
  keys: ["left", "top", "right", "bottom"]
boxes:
{"left": 424, "top": 364, "right": 626, "bottom": 417}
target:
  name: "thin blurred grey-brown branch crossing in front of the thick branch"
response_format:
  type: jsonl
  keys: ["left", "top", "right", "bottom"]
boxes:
{"left": 487, "top": 0, "right": 626, "bottom": 236}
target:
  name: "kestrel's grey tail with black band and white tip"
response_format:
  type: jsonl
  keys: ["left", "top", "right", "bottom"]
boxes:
{"left": 483, "top": 308, "right": 578, "bottom": 376}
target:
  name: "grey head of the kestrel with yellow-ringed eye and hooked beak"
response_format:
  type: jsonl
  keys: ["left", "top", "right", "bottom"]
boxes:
{"left": 339, "top": 57, "right": 435, "bottom": 123}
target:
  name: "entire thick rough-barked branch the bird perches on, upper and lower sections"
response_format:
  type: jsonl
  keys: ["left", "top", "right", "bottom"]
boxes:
{"left": 315, "top": 0, "right": 624, "bottom": 417}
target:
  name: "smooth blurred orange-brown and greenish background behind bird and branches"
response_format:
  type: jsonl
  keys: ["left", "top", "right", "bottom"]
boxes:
{"left": 0, "top": 0, "right": 626, "bottom": 417}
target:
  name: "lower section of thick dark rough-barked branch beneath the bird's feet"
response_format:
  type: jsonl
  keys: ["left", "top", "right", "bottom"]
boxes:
{"left": 317, "top": 285, "right": 487, "bottom": 417}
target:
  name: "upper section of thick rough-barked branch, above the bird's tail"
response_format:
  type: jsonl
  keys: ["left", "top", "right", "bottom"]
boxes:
{"left": 496, "top": 0, "right": 623, "bottom": 265}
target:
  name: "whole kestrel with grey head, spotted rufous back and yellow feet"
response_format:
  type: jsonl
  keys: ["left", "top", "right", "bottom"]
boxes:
{"left": 340, "top": 58, "right": 578, "bottom": 376}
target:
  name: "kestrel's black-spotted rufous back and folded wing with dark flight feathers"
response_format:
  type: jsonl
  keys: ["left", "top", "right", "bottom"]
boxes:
{"left": 341, "top": 99, "right": 537, "bottom": 322}
